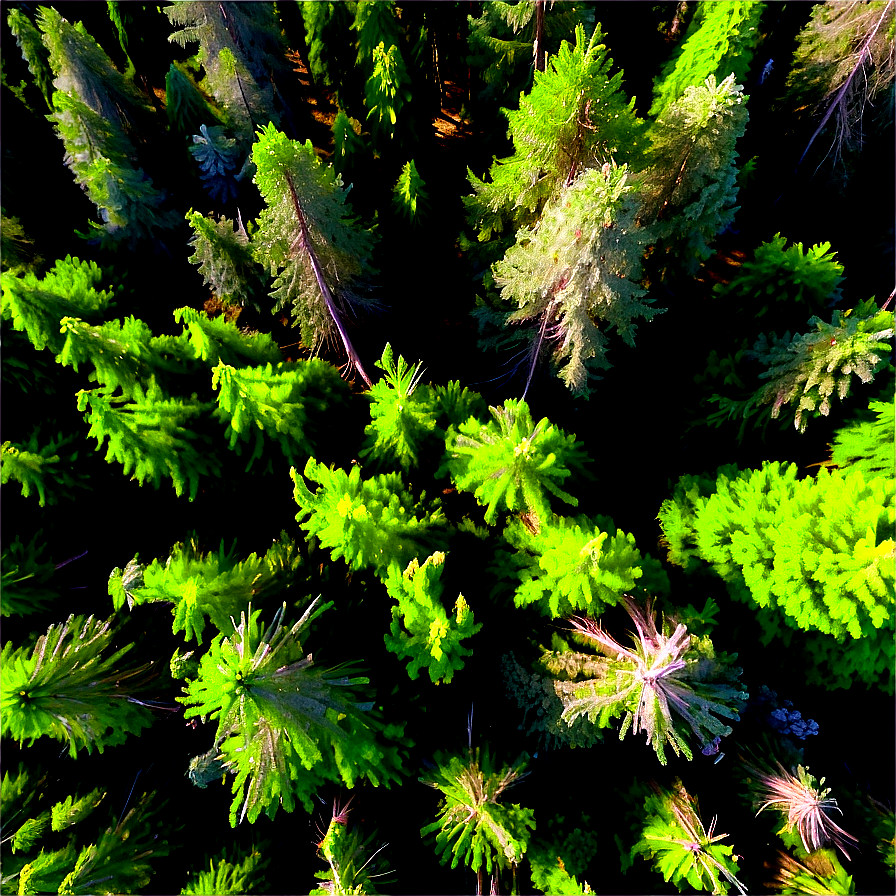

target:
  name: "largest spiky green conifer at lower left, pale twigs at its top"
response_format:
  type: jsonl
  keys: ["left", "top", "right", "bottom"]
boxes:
{"left": 178, "top": 599, "right": 403, "bottom": 826}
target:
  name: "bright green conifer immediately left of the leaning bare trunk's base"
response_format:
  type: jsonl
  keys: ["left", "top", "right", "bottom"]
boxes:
{"left": 212, "top": 356, "right": 348, "bottom": 472}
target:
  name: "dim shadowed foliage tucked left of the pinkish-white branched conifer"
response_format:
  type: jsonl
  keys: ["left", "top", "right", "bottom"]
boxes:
{"left": 501, "top": 652, "right": 603, "bottom": 750}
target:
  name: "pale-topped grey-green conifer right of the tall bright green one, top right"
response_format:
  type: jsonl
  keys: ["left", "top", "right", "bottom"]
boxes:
{"left": 640, "top": 75, "right": 748, "bottom": 274}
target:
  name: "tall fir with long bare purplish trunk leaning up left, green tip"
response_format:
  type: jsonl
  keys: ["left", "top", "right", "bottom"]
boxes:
{"left": 252, "top": 125, "right": 373, "bottom": 385}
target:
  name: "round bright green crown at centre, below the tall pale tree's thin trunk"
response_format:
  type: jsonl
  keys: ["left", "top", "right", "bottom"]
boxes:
{"left": 436, "top": 399, "right": 586, "bottom": 524}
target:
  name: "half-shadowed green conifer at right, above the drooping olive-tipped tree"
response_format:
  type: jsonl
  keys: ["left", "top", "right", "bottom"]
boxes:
{"left": 714, "top": 233, "right": 843, "bottom": 317}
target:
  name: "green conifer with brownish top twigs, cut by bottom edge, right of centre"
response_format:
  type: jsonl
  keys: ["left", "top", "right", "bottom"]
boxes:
{"left": 631, "top": 779, "right": 747, "bottom": 894}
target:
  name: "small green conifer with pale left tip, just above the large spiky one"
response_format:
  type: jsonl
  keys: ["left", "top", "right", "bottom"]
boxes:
{"left": 108, "top": 532, "right": 300, "bottom": 644}
